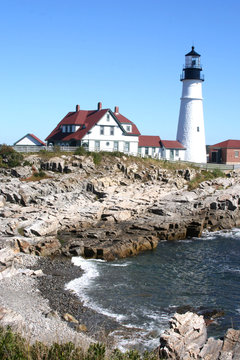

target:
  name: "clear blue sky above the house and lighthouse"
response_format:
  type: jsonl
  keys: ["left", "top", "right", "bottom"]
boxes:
{"left": 0, "top": 0, "right": 240, "bottom": 145}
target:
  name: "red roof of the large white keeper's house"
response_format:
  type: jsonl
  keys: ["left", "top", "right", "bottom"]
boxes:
{"left": 46, "top": 109, "right": 140, "bottom": 141}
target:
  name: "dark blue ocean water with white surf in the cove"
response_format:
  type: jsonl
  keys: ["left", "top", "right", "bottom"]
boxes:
{"left": 66, "top": 229, "right": 240, "bottom": 351}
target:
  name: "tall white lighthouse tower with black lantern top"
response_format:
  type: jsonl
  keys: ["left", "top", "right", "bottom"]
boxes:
{"left": 177, "top": 46, "right": 206, "bottom": 163}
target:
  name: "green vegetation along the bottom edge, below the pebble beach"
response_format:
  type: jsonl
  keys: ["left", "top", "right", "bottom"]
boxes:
{"left": 0, "top": 327, "right": 161, "bottom": 360}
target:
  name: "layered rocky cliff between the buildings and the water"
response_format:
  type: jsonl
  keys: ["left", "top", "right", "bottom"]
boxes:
{"left": 0, "top": 155, "right": 240, "bottom": 260}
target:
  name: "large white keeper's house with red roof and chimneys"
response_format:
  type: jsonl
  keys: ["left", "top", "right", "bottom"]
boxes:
{"left": 46, "top": 102, "right": 140, "bottom": 155}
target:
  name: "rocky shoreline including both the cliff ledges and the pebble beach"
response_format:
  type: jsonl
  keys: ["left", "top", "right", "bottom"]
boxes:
{"left": 0, "top": 155, "right": 240, "bottom": 356}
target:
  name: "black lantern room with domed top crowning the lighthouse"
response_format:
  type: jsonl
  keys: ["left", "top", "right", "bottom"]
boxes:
{"left": 181, "top": 46, "right": 204, "bottom": 81}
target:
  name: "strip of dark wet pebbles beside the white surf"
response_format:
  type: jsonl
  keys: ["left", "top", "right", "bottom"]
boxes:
{"left": 33, "top": 256, "right": 126, "bottom": 347}
